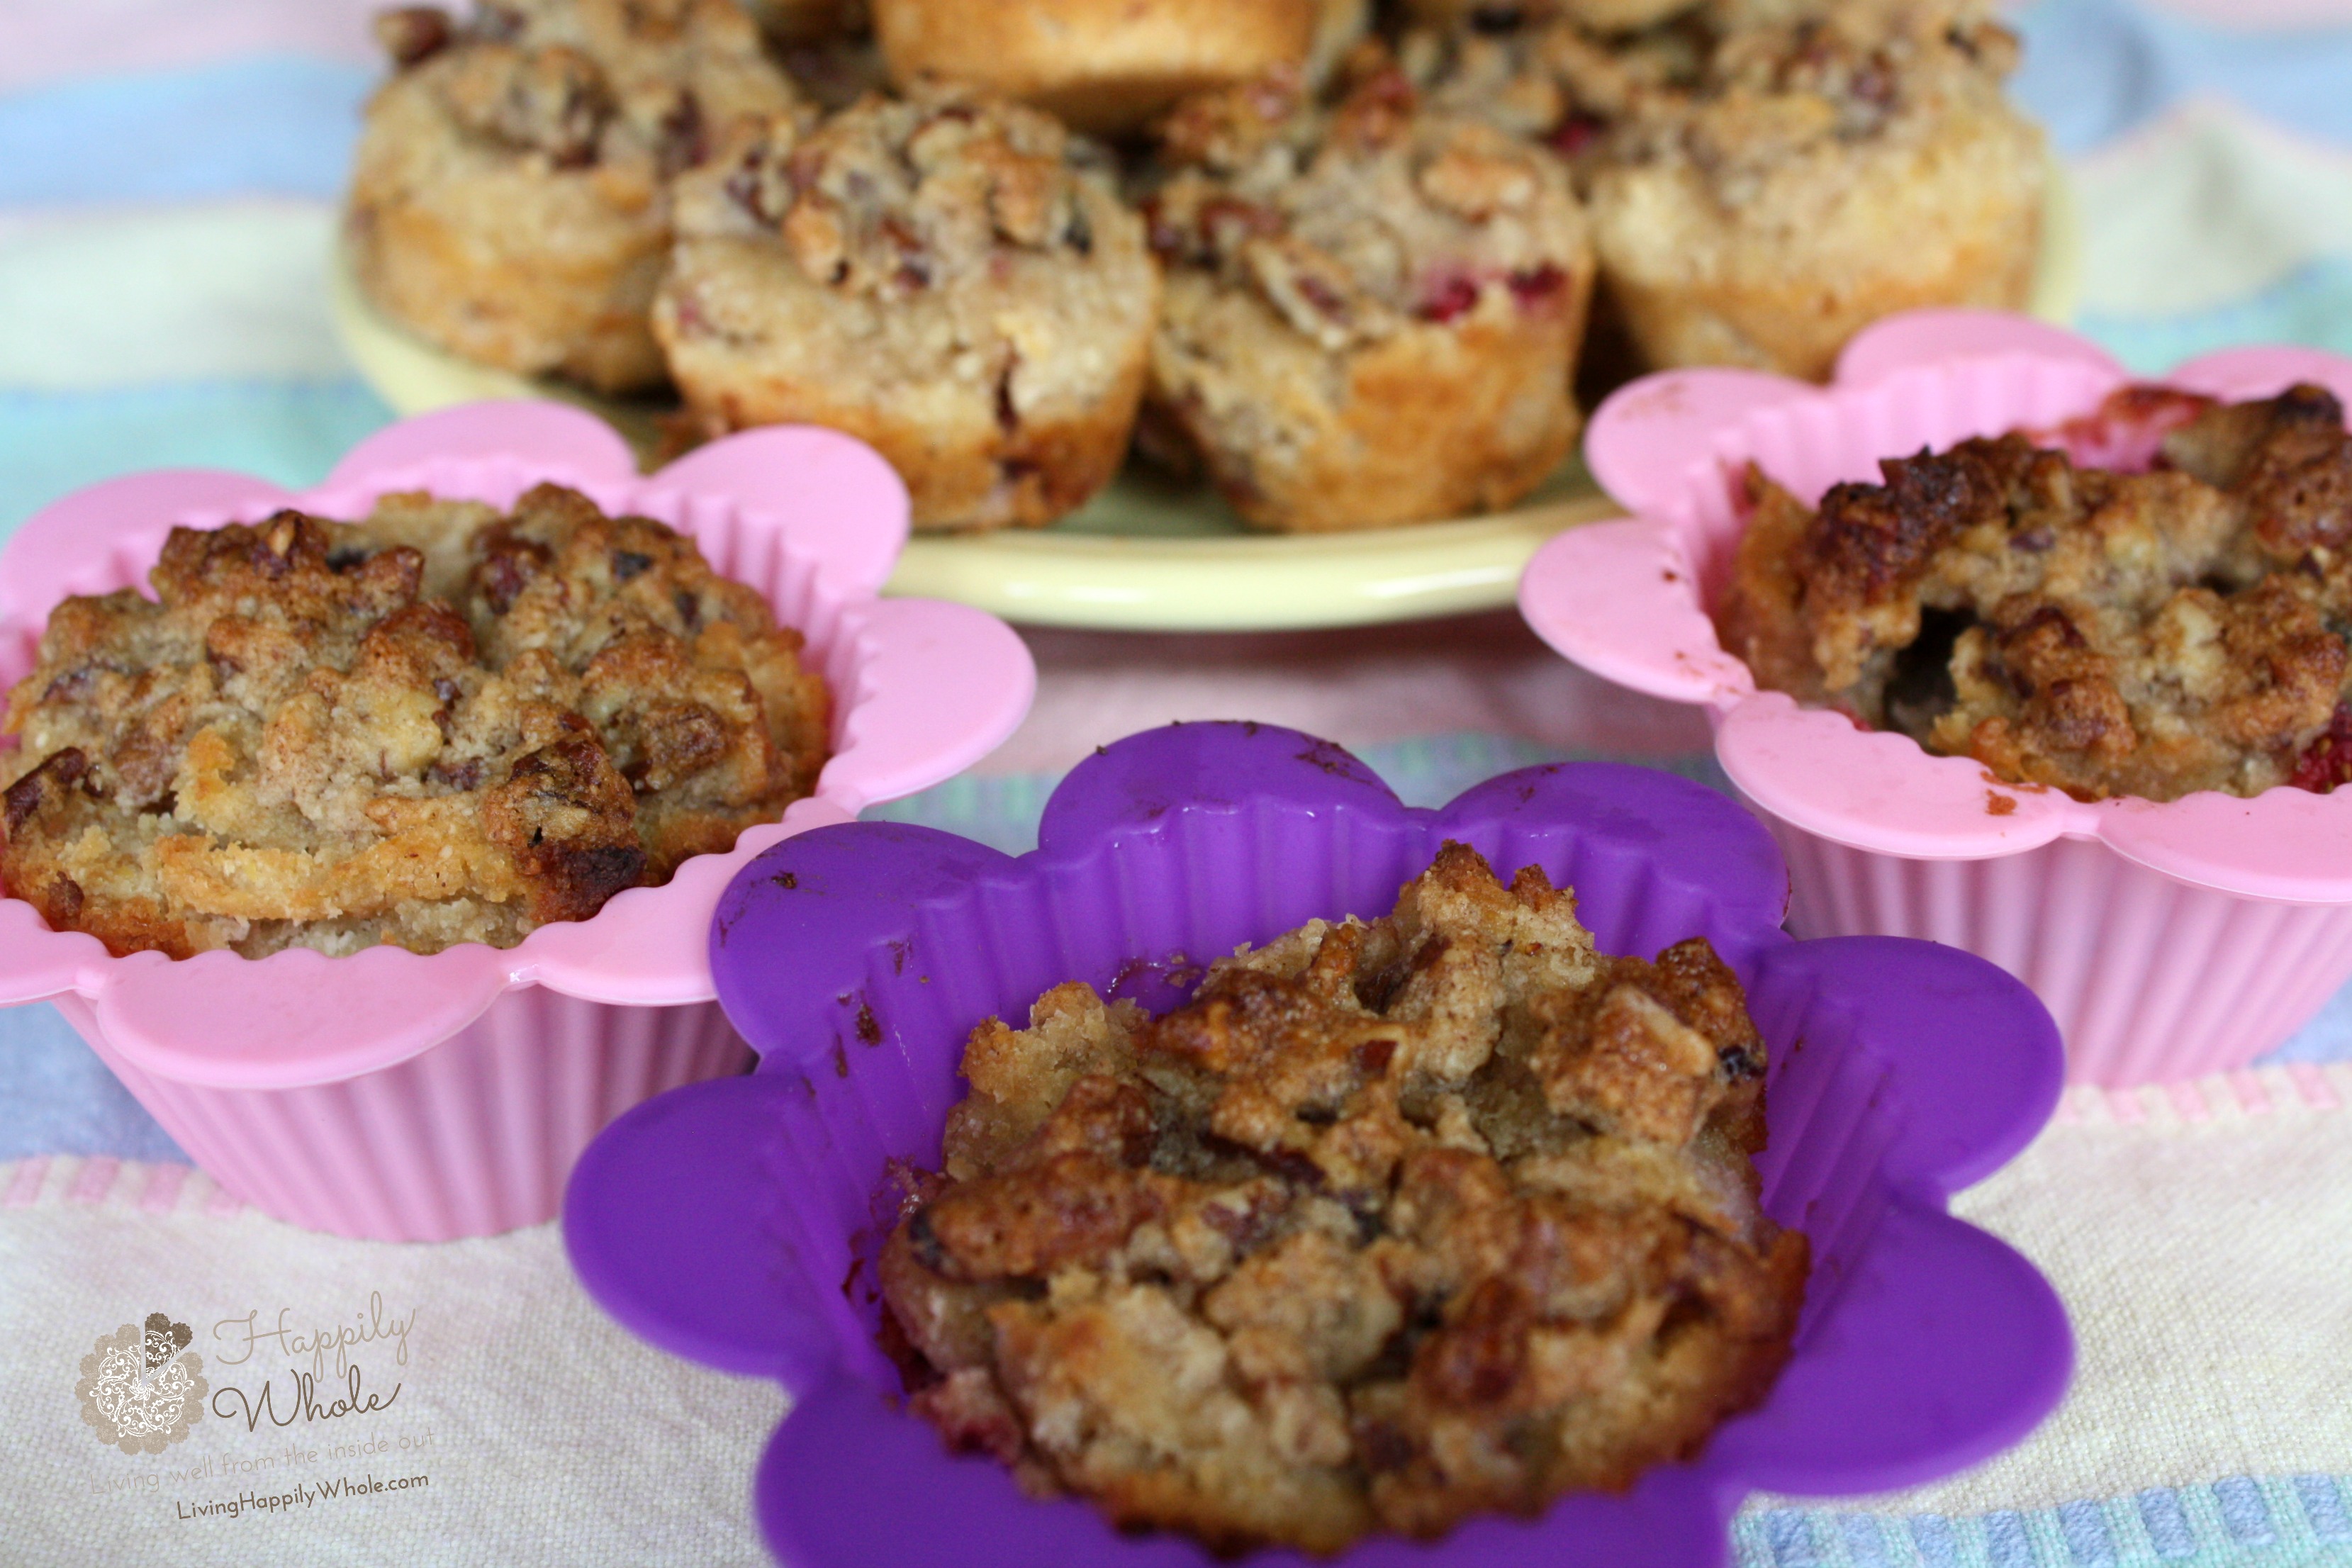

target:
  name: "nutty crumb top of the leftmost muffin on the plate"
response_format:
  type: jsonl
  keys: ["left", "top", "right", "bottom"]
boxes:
{"left": 376, "top": 0, "right": 797, "bottom": 181}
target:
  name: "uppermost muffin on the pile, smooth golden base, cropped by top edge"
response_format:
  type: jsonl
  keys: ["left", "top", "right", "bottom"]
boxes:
{"left": 873, "top": 0, "right": 1367, "bottom": 134}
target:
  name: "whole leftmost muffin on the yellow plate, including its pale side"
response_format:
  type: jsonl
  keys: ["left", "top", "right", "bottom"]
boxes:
{"left": 346, "top": 0, "right": 795, "bottom": 393}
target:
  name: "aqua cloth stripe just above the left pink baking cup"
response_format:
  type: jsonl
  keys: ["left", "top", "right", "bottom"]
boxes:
{"left": 0, "top": 381, "right": 393, "bottom": 534}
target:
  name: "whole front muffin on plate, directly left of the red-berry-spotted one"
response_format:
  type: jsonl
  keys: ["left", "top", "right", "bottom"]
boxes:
{"left": 654, "top": 87, "right": 1160, "bottom": 529}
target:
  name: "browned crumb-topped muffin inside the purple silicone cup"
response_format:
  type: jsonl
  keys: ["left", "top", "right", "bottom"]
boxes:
{"left": 880, "top": 844, "right": 1806, "bottom": 1552}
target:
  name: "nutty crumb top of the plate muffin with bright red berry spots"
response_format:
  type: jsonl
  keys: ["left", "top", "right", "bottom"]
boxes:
{"left": 1143, "top": 61, "right": 1590, "bottom": 352}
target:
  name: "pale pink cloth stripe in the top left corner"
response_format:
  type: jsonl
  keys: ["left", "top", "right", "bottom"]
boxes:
{"left": 0, "top": 0, "right": 381, "bottom": 91}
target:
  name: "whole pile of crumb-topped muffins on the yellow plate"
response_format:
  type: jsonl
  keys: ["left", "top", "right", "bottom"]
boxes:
{"left": 350, "top": 0, "right": 2044, "bottom": 531}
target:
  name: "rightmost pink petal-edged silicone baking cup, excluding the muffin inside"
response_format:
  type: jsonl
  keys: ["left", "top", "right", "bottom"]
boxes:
{"left": 1519, "top": 310, "right": 2352, "bottom": 1086}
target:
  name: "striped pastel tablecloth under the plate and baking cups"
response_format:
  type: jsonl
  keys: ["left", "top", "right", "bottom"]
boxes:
{"left": 0, "top": 0, "right": 2352, "bottom": 1568}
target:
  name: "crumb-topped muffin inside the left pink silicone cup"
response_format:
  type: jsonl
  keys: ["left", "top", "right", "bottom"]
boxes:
{"left": 0, "top": 484, "right": 828, "bottom": 957}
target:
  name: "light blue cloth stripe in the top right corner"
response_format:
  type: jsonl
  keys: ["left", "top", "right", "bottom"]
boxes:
{"left": 2011, "top": 0, "right": 2352, "bottom": 153}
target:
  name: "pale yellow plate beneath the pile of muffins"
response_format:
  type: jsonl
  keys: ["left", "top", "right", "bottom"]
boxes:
{"left": 330, "top": 164, "right": 2081, "bottom": 632}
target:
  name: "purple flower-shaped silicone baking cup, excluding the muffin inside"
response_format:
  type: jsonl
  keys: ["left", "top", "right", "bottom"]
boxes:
{"left": 564, "top": 724, "right": 2072, "bottom": 1568}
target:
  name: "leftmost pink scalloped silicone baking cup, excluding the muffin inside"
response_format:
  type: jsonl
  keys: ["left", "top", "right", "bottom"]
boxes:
{"left": 0, "top": 402, "right": 1035, "bottom": 1241}
